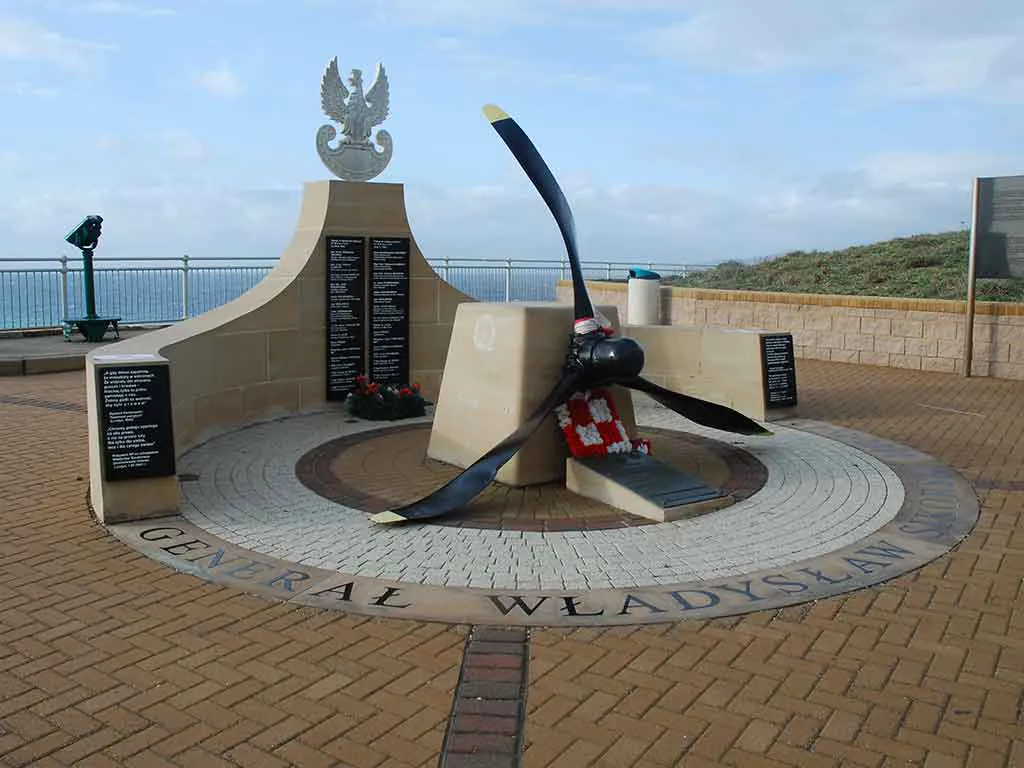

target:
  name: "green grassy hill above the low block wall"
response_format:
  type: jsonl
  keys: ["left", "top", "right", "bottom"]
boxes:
{"left": 665, "top": 231, "right": 1024, "bottom": 301}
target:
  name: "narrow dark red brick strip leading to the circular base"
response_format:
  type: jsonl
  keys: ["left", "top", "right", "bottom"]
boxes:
{"left": 439, "top": 627, "right": 529, "bottom": 768}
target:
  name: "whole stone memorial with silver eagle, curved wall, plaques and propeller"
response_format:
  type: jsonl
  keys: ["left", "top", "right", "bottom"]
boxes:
{"left": 86, "top": 59, "right": 792, "bottom": 523}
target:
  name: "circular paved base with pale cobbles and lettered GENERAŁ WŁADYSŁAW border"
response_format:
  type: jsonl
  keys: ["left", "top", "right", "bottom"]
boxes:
{"left": 111, "top": 409, "right": 978, "bottom": 625}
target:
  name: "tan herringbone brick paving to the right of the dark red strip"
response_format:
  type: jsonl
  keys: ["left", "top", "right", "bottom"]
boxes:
{"left": 524, "top": 360, "right": 1024, "bottom": 768}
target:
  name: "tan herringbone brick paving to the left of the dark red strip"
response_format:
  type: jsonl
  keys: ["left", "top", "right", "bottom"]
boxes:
{"left": 0, "top": 373, "right": 465, "bottom": 768}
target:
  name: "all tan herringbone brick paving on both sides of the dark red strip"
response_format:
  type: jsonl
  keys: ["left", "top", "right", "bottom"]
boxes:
{"left": 0, "top": 361, "right": 1024, "bottom": 768}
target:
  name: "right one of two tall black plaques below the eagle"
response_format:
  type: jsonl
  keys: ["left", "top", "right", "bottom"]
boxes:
{"left": 370, "top": 238, "right": 410, "bottom": 385}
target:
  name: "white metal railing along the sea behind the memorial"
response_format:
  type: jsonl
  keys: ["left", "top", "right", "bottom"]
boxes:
{"left": 0, "top": 256, "right": 707, "bottom": 330}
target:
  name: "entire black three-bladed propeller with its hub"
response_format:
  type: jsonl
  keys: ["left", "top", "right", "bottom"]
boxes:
{"left": 370, "top": 104, "right": 771, "bottom": 523}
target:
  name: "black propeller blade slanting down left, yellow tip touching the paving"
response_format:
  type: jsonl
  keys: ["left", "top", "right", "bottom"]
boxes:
{"left": 370, "top": 368, "right": 583, "bottom": 523}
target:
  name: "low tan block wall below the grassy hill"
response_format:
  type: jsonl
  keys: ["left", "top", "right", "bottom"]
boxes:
{"left": 558, "top": 281, "right": 1024, "bottom": 380}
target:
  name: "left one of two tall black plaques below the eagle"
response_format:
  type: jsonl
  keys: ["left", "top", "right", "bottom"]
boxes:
{"left": 327, "top": 238, "right": 367, "bottom": 400}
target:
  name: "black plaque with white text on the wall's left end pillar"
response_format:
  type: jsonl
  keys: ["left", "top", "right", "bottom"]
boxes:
{"left": 96, "top": 365, "right": 175, "bottom": 481}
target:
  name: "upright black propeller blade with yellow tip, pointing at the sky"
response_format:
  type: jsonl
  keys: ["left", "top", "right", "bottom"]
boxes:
{"left": 483, "top": 104, "right": 594, "bottom": 321}
